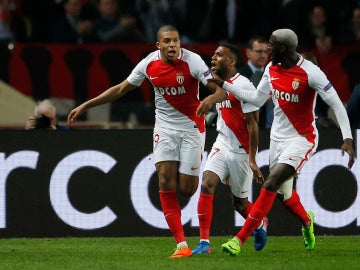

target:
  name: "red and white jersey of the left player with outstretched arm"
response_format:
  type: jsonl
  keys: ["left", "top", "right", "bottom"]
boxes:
{"left": 127, "top": 48, "right": 212, "bottom": 132}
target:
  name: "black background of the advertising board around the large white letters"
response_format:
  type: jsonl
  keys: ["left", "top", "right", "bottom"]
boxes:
{"left": 0, "top": 128, "right": 360, "bottom": 237}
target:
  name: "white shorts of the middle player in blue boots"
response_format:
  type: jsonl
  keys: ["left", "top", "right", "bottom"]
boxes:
{"left": 204, "top": 141, "right": 253, "bottom": 198}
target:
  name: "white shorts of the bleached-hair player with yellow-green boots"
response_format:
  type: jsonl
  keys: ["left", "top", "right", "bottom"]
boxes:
{"left": 269, "top": 137, "right": 317, "bottom": 173}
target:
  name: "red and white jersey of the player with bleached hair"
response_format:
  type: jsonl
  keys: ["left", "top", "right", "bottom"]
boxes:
{"left": 257, "top": 56, "right": 337, "bottom": 143}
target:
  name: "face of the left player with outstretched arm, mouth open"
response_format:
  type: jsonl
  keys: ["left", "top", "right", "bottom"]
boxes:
{"left": 156, "top": 31, "right": 181, "bottom": 64}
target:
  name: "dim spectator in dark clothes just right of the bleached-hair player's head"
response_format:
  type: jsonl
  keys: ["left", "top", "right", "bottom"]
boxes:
{"left": 302, "top": 5, "right": 334, "bottom": 54}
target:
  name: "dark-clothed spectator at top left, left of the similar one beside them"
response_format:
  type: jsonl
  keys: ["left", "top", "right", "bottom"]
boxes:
{"left": 52, "top": 0, "right": 97, "bottom": 44}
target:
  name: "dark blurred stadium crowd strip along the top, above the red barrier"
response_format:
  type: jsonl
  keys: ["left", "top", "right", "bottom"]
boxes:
{"left": 0, "top": 0, "right": 360, "bottom": 46}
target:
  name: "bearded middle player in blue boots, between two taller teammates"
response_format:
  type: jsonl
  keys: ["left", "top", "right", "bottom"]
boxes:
{"left": 193, "top": 42, "right": 267, "bottom": 254}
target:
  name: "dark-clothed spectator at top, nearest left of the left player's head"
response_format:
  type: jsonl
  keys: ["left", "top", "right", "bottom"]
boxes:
{"left": 94, "top": 0, "right": 146, "bottom": 43}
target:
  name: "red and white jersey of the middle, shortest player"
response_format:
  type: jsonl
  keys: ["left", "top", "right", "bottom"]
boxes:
{"left": 216, "top": 73, "right": 259, "bottom": 154}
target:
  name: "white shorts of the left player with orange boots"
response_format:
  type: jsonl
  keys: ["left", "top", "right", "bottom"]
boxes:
{"left": 153, "top": 127, "right": 205, "bottom": 176}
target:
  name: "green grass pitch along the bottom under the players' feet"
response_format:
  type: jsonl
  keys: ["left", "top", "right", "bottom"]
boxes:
{"left": 0, "top": 235, "right": 360, "bottom": 270}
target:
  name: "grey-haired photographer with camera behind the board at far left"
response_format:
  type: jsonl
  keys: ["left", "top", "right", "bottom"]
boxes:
{"left": 25, "top": 99, "right": 70, "bottom": 130}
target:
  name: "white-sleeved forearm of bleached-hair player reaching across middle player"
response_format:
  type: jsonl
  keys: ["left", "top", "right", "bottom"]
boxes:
{"left": 222, "top": 82, "right": 269, "bottom": 107}
